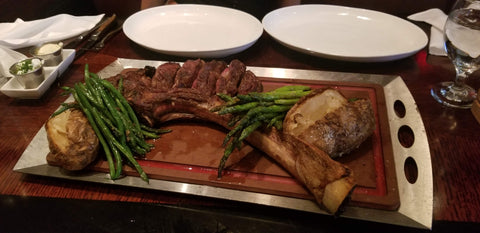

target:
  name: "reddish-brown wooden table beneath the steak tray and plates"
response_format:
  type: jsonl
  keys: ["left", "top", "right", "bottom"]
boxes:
{"left": 0, "top": 14, "right": 480, "bottom": 232}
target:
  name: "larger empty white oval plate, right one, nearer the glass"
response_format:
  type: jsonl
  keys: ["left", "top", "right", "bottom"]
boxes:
{"left": 262, "top": 4, "right": 428, "bottom": 62}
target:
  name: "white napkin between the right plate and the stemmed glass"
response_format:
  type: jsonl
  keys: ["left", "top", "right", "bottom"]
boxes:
{"left": 407, "top": 8, "right": 448, "bottom": 56}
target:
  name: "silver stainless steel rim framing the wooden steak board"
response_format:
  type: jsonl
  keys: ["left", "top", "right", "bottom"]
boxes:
{"left": 13, "top": 58, "right": 433, "bottom": 229}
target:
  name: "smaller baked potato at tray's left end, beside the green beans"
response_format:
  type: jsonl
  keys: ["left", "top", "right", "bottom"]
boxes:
{"left": 45, "top": 109, "right": 99, "bottom": 171}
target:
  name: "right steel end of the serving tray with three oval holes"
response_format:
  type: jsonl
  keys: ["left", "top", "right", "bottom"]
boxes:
{"left": 384, "top": 79, "right": 433, "bottom": 229}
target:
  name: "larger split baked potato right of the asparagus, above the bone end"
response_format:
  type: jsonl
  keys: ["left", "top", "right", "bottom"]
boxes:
{"left": 283, "top": 88, "right": 375, "bottom": 158}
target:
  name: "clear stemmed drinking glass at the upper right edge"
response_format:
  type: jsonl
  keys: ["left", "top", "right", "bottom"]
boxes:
{"left": 431, "top": 0, "right": 480, "bottom": 108}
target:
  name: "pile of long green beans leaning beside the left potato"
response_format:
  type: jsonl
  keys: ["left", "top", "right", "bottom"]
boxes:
{"left": 52, "top": 65, "right": 170, "bottom": 182}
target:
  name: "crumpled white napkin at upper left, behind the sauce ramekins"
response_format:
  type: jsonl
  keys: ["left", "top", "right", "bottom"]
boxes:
{"left": 0, "top": 14, "right": 104, "bottom": 49}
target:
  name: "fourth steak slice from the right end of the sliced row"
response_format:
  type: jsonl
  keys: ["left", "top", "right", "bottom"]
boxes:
{"left": 173, "top": 59, "right": 205, "bottom": 88}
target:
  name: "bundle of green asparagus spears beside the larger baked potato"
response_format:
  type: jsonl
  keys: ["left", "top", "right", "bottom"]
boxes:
{"left": 212, "top": 85, "right": 311, "bottom": 178}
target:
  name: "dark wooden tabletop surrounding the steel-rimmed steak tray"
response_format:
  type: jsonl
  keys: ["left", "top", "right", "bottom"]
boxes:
{"left": 0, "top": 0, "right": 480, "bottom": 232}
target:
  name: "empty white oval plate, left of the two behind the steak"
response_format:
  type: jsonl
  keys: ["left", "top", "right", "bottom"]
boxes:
{"left": 123, "top": 4, "right": 263, "bottom": 58}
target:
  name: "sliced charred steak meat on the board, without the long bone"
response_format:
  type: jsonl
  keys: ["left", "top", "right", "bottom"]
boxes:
{"left": 107, "top": 59, "right": 263, "bottom": 126}
